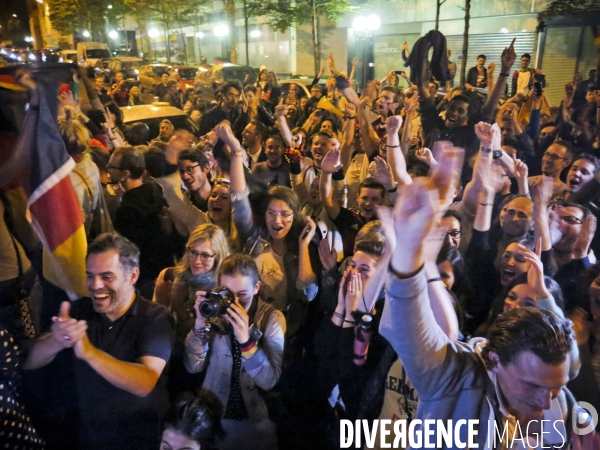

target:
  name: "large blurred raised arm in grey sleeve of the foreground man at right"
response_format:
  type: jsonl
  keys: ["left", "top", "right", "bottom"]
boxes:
{"left": 379, "top": 148, "right": 463, "bottom": 398}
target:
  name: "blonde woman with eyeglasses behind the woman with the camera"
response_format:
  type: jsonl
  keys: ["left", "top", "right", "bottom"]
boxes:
{"left": 152, "top": 223, "right": 230, "bottom": 391}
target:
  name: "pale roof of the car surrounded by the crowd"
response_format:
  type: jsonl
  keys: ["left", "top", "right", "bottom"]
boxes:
{"left": 121, "top": 104, "right": 200, "bottom": 139}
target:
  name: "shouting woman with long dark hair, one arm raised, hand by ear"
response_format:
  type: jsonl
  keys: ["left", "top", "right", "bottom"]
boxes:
{"left": 215, "top": 124, "right": 321, "bottom": 336}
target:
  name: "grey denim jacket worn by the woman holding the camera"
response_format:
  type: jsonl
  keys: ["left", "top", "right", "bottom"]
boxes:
{"left": 184, "top": 297, "right": 285, "bottom": 422}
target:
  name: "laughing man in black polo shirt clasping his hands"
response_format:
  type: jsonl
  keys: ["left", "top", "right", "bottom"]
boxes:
{"left": 25, "top": 233, "right": 174, "bottom": 450}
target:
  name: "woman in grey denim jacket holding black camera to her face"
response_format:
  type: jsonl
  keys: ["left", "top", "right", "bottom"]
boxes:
{"left": 184, "top": 254, "right": 285, "bottom": 450}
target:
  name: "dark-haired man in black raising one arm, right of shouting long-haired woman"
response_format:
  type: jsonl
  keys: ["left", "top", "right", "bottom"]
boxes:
{"left": 319, "top": 149, "right": 385, "bottom": 257}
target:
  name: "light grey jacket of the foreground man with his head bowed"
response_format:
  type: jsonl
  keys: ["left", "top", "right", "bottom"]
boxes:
{"left": 379, "top": 269, "right": 574, "bottom": 449}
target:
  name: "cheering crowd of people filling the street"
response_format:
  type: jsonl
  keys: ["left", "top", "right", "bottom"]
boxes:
{"left": 0, "top": 32, "right": 600, "bottom": 450}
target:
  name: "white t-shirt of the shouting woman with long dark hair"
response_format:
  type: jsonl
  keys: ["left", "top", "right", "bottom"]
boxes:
{"left": 254, "top": 246, "right": 288, "bottom": 311}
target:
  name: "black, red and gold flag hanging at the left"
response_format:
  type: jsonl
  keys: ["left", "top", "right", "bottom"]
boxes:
{"left": 13, "top": 80, "right": 87, "bottom": 299}
